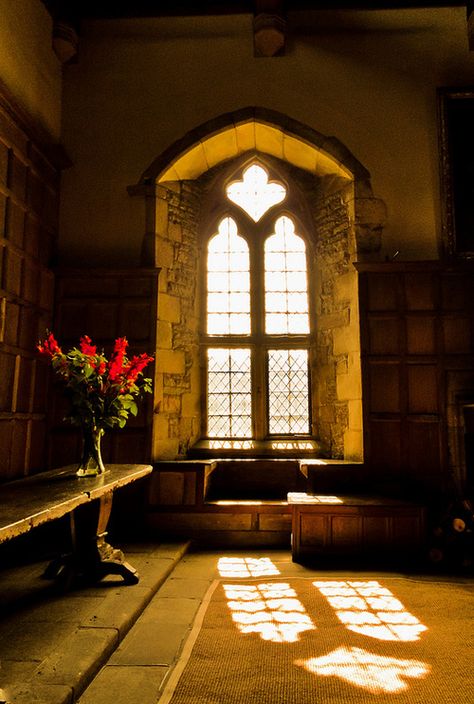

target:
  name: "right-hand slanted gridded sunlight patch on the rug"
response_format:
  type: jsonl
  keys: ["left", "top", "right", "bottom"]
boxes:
{"left": 313, "top": 580, "right": 427, "bottom": 641}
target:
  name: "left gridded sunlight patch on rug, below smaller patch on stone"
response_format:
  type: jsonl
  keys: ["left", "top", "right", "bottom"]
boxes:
{"left": 223, "top": 582, "right": 316, "bottom": 643}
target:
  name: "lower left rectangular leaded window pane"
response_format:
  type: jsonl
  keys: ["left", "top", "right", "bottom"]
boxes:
{"left": 207, "top": 347, "right": 252, "bottom": 438}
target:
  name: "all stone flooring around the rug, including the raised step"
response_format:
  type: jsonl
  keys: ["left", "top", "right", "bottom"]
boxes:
{"left": 0, "top": 543, "right": 472, "bottom": 704}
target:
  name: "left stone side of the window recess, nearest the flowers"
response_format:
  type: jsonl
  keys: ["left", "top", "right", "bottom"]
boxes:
{"left": 153, "top": 181, "right": 200, "bottom": 458}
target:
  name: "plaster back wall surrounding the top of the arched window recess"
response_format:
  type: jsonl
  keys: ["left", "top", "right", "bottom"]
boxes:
{"left": 60, "top": 7, "right": 474, "bottom": 265}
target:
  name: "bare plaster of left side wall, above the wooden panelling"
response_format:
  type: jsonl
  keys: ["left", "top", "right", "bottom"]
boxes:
{"left": 0, "top": 0, "right": 62, "bottom": 141}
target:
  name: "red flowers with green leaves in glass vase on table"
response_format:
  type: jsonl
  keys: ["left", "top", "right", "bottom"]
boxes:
{"left": 37, "top": 333, "right": 153, "bottom": 476}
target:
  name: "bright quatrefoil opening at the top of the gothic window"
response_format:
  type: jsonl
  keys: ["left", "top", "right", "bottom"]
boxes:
{"left": 227, "top": 164, "right": 286, "bottom": 222}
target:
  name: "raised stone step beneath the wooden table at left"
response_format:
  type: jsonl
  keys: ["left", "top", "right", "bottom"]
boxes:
{"left": 0, "top": 543, "right": 188, "bottom": 704}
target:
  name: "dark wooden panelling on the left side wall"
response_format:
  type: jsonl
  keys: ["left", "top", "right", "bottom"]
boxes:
{"left": 0, "top": 96, "right": 61, "bottom": 482}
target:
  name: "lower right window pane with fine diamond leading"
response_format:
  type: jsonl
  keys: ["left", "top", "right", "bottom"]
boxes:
{"left": 268, "top": 350, "right": 309, "bottom": 435}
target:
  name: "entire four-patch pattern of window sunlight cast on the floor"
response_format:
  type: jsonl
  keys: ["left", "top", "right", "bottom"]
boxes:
{"left": 218, "top": 557, "right": 431, "bottom": 695}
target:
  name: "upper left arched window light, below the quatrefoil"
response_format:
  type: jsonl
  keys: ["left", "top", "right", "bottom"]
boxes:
{"left": 207, "top": 218, "right": 250, "bottom": 335}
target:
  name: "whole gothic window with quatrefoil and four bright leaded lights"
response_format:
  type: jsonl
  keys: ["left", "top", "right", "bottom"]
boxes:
{"left": 201, "top": 159, "right": 314, "bottom": 449}
